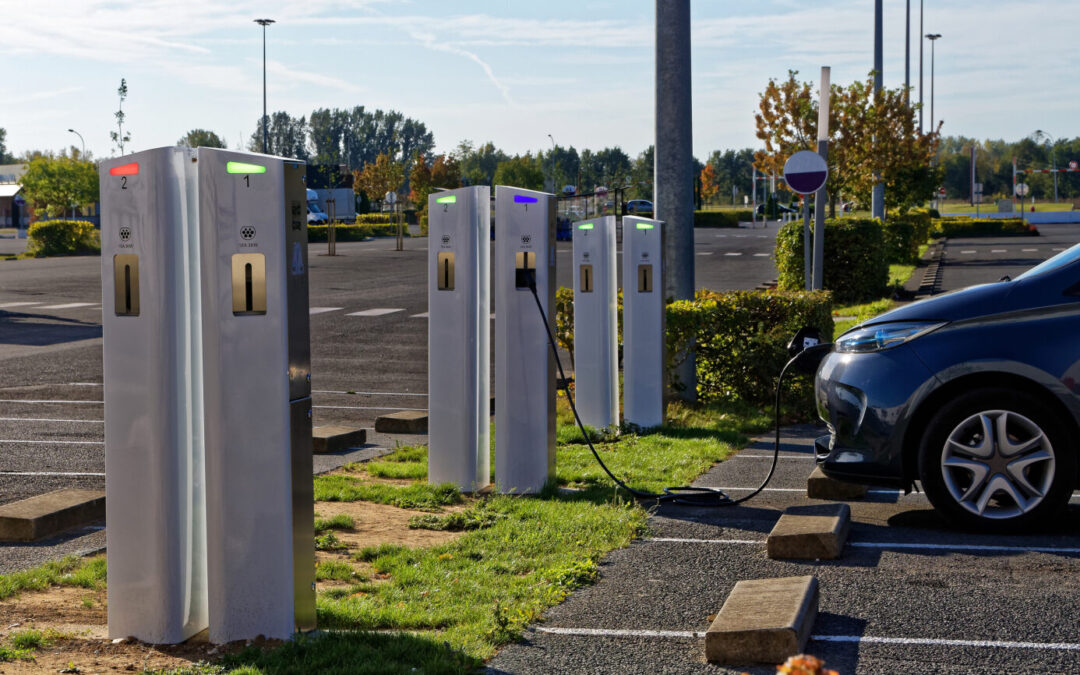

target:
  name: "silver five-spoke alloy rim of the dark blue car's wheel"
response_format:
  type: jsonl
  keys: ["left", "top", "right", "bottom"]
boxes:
{"left": 941, "top": 410, "right": 1055, "bottom": 519}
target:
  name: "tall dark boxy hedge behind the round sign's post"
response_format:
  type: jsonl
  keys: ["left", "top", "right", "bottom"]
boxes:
{"left": 777, "top": 218, "right": 889, "bottom": 305}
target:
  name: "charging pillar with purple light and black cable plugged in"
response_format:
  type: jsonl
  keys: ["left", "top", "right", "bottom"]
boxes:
{"left": 495, "top": 186, "right": 555, "bottom": 495}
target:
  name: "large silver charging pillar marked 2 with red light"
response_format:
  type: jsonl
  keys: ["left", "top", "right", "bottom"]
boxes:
{"left": 99, "top": 148, "right": 207, "bottom": 644}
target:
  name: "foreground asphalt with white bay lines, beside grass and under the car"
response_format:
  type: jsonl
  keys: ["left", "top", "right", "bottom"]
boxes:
{"left": 490, "top": 427, "right": 1080, "bottom": 673}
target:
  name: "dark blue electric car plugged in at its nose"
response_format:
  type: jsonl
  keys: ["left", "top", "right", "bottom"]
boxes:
{"left": 815, "top": 239, "right": 1080, "bottom": 530}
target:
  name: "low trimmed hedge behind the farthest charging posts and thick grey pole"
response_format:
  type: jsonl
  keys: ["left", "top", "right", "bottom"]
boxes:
{"left": 555, "top": 287, "right": 833, "bottom": 414}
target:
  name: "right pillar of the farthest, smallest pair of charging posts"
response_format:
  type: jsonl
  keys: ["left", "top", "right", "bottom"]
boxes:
{"left": 622, "top": 216, "right": 664, "bottom": 429}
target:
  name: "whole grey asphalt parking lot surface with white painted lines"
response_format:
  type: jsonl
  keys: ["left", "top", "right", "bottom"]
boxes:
{"left": 0, "top": 221, "right": 1080, "bottom": 673}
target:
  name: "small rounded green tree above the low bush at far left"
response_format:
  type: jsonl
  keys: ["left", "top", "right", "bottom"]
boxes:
{"left": 18, "top": 154, "right": 98, "bottom": 216}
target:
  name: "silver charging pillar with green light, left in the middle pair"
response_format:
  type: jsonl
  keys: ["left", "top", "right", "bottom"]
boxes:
{"left": 428, "top": 186, "right": 494, "bottom": 492}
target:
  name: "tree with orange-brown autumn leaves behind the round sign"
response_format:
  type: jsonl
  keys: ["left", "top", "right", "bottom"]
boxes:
{"left": 754, "top": 70, "right": 941, "bottom": 217}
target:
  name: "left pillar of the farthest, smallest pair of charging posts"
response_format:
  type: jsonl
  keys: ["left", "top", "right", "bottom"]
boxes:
{"left": 573, "top": 216, "right": 619, "bottom": 429}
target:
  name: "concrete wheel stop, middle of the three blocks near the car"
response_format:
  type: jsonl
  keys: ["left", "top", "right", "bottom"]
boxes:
{"left": 766, "top": 504, "right": 851, "bottom": 561}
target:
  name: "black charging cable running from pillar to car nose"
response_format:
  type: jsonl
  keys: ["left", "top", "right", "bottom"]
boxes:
{"left": 527, "top": 270, "right": 833, "bottom": 507}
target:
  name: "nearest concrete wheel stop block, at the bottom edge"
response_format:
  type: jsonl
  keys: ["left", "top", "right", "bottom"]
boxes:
{"left": 705, "top": 577, "right": 818, "bottom": 665}
